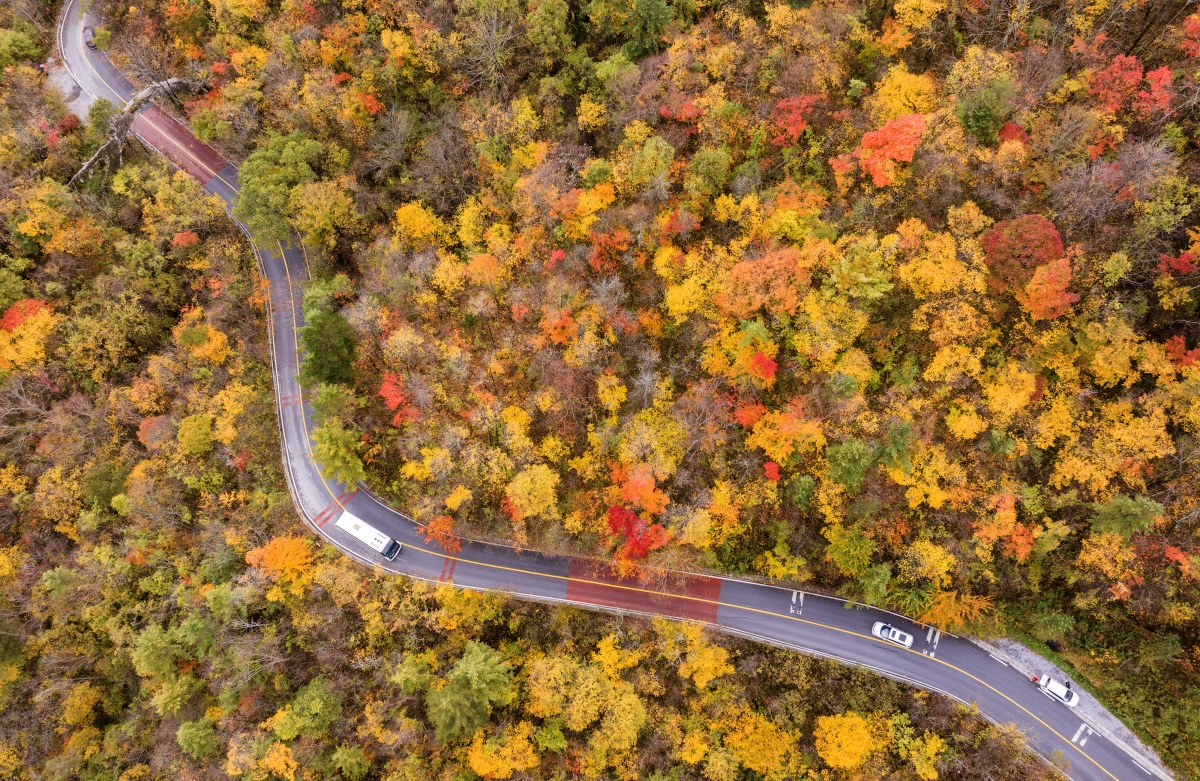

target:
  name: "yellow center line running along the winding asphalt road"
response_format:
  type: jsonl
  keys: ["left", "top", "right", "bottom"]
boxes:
{"left": 72, "top": 15, "right": 1120, "bottom": 781}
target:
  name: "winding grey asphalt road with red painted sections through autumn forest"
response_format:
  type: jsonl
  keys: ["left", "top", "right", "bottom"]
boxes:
{"left": 51, "top": 0, "right": 1169, "bottom": 781}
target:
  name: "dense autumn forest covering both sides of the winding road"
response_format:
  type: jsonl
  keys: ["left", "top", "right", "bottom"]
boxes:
{"left": 0, "top": 0, "right": 1200, "bottom": 781}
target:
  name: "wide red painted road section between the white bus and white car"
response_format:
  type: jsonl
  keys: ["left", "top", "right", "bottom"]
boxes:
{"left": 566, "top": 559, "right": 721, "bottom": 624}
